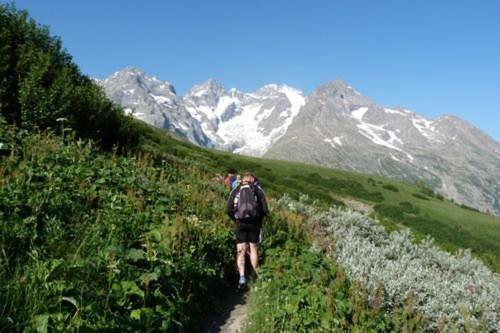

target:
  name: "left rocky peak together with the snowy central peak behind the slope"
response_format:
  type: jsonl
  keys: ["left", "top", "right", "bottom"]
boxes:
{"left": 97, "top": 68, "right": 304, "bottom": 156}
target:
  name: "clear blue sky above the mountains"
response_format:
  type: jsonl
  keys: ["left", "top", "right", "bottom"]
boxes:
{"left": 9, "top": 0, "right": 500, "bottom": 140}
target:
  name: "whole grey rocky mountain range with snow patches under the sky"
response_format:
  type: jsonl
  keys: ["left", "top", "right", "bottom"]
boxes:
{"left": 98, "top": 68, "right": 500, "bottom": 215}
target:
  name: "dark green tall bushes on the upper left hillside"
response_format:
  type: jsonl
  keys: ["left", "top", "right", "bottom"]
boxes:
{"left": 0, "top": 4, "right": 139, "bottom": 148}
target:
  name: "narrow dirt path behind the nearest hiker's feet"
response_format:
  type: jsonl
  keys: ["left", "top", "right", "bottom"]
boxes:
{"left": 202, "top": 290, "right": 248, "bottom": 333}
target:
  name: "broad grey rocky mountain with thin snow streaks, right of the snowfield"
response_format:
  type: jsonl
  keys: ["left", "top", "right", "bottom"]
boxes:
{"left": 265, "top": 81, "right": 500, "bottom": 214}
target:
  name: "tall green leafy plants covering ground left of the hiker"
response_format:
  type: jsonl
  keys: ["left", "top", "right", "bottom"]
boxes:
{"left": 0, "top": 127, "right": 234, "bottom": 332}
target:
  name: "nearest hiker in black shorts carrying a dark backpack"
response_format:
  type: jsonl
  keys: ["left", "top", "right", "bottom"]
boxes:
{"left": 227, "top": 173, "right": 269, "bottom": 288}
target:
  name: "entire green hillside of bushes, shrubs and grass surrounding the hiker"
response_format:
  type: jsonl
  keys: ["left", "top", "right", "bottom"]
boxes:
{"left": 0, "top": 4, "right": 500, "bottom": 333}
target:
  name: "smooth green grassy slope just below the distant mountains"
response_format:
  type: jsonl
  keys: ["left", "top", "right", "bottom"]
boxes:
{"left": 140, "top": 124, "right": 500, "bottom": 272}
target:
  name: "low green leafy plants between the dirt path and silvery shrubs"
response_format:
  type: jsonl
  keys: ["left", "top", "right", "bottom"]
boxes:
{"left": 246, "top": 204, "right": 422, "bottom": 332}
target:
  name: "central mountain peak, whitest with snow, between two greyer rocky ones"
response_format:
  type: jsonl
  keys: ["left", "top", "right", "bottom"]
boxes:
{"left": 183, "top": 80, "right": 304, "bottom": 156}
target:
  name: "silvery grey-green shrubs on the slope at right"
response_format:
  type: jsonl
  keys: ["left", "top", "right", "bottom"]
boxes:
{"left": 281, "top": 198, "right": 500, "bottom": 332}
